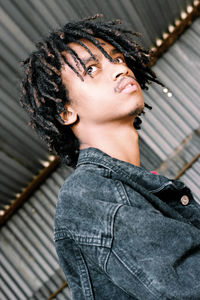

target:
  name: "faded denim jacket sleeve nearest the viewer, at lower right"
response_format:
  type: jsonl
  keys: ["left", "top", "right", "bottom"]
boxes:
{"left": 105, "top": 205, "right": 200, "bottom": 300}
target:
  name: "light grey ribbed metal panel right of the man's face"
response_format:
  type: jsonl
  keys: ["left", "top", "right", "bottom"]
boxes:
{"left": 140, "top": 19, "right": 200, "bottom": 161}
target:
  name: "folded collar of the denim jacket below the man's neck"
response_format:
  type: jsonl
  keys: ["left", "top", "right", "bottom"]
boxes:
{"left": 77, "top": 148, "right": 191, "bottom": 221}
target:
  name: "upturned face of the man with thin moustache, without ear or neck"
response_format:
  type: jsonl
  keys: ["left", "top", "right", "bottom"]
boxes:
{"left": 62, "top": 39, "right": 144, "bottom": 126}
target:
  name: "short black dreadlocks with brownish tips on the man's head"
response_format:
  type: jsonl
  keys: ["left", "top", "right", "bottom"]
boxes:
{"left": 20, "top": 15, "right": 163, "bottom": 167}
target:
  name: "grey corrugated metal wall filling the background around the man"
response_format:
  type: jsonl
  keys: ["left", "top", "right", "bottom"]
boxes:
{"left": 0, "top": 0, "right": 200, "bottom": 300}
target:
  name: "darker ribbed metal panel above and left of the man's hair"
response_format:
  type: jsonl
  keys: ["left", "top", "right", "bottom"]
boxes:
{"left": 0, "top": 0, "right": 195, "bottom": 209}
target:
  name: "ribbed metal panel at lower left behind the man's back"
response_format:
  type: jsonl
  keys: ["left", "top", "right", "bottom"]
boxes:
{"left": 0, "top": 168, "right": 71, "bottom": 300}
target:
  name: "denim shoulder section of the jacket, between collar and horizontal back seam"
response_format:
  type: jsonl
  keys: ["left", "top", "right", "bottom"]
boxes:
{"left": 54, "top": 164, "right": 122, "bottom": 245}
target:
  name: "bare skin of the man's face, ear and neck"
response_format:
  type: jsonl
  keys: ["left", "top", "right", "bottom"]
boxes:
{"left": 60, "top": 39, "right": 144, "bottom": 166}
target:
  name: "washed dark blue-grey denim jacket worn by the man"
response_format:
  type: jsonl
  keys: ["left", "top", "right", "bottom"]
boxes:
{"left": 54, "top": 148, "right": 200, "bottom": 300}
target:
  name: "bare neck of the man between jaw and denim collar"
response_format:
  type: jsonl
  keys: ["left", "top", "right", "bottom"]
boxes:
{"left": 79, "top": 122, "right": 140, "bottom": 166}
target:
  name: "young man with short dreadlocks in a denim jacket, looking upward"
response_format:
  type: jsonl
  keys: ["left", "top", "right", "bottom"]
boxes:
{"left": 21, "top": 18, "right": 200, "bottom": 300}
